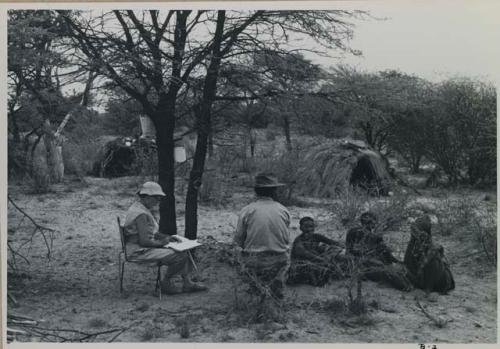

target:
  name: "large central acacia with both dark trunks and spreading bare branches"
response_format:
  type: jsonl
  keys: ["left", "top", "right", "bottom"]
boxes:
{"left": 61, "top": 10, "right": 364, "bottom": 237}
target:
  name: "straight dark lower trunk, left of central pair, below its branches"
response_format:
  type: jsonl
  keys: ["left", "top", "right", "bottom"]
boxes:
{"left": 156, "top": 99, "right": 177, "bottom": 235}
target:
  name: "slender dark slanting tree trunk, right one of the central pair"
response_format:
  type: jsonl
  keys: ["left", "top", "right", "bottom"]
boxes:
{"left": 185, "top": 11, "right": 226, "bottom": 239}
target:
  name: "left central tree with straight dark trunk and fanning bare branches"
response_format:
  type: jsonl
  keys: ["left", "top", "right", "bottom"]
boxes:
{"left": 61, "top": 10, "right": 217, "bottom": 234}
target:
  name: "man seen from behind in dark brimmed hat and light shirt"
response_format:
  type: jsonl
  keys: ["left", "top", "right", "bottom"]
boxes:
{"left": 234, "top": 173, "right": 291, "bottom": 299}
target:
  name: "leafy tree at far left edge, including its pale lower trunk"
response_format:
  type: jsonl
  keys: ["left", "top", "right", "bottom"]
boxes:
{"left": 7, "top": 10, "right": 95, "bottom": 188}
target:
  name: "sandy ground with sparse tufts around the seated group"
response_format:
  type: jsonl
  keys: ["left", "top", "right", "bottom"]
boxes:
{"left": 8, "top": 178, "right": 497, "bottom": 343}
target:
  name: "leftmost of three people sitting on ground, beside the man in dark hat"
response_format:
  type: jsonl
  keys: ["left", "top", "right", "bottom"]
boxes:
{"left": 288, "top": 217, "right": 346, "bottom": 286}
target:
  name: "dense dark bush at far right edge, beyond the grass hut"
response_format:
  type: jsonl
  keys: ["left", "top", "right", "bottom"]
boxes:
{"left": 424, "top": 78, "right": 497, "bottom": 185}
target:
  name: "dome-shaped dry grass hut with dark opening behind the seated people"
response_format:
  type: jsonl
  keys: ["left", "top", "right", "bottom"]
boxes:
{"left": 299, "top": 139, "right": 392, "bottom": 197}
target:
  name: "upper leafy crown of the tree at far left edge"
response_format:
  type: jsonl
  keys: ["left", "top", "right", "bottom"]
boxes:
{"left": 7, "top": 10, "right": 71, "bottom": 140}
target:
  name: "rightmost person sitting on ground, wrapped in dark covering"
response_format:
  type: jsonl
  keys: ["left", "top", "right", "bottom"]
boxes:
{"left": 404, "top": 215, "right": 455, "bottom": 293}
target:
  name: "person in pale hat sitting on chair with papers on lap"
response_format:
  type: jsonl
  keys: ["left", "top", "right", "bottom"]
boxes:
{"left": 123, "top": 182, "right": 207, "bottom": 294}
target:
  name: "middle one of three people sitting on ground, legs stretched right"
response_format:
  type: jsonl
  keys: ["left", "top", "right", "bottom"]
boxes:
{"left": 346, "top": 212, "right": 412, "bottom": 291}
